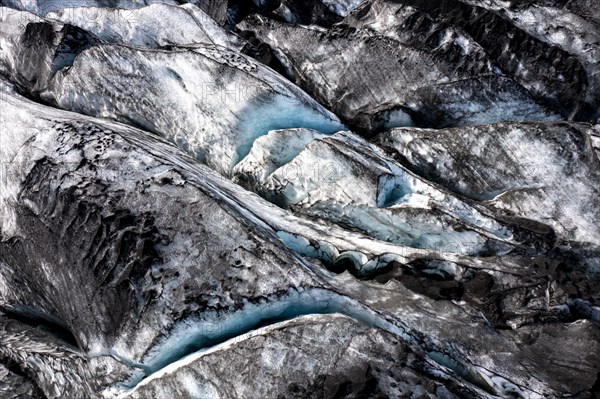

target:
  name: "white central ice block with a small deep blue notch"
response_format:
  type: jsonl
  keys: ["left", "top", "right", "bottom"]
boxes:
{"left": 234, "top": 130, "right": 515, "bottom": 254}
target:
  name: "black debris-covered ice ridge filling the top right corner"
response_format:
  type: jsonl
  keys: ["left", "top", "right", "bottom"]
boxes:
{"left": 354, "top": 0, "right": 600, "bottom": 122}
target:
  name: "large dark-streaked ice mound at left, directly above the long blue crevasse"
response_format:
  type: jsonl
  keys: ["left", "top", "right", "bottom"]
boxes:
{"left": 0, "top": 81, "right": 564, "bottom": 399}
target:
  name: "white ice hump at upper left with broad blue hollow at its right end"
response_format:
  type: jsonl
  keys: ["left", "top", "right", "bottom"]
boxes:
{"left": 43, "top": 45, "right": 343, "bottom": 174}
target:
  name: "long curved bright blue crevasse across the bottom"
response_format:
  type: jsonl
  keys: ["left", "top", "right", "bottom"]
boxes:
{"left": 111, "top": 289, "right": 528, "bottom": 397}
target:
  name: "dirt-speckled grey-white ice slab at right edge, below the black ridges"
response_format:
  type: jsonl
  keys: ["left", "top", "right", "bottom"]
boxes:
{"left": 376, "top": 122, "right": 600, "bottom": 245}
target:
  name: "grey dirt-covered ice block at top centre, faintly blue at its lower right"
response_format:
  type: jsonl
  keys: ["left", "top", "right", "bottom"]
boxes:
{"left": 240, "top": 10, "right": 557, "bottom": 135}
